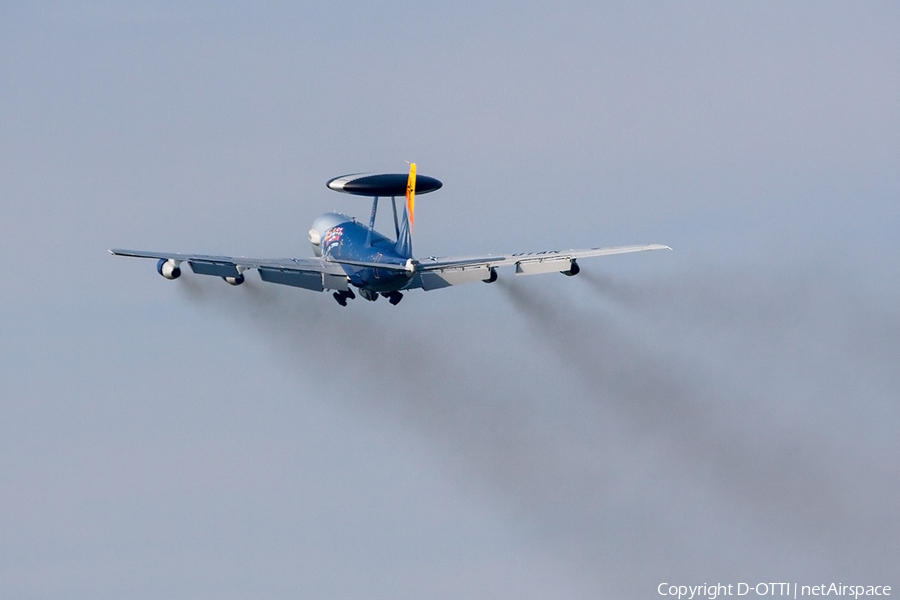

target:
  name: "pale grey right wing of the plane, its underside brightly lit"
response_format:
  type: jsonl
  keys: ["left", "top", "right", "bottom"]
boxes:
{"left": 406, "top": 244, "right": 671, "bottom": 290}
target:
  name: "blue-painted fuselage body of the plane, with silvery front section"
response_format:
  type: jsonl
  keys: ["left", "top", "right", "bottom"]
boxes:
{"left": 313, "top": 213, "right": 413, "bottom": 292}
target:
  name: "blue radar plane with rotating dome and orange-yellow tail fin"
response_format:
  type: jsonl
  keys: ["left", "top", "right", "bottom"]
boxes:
{"left": 109, "top": 163, "right": 671, "bottom": 306}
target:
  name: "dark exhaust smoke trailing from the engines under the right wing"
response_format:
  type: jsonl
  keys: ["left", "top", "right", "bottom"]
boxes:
{"left": 502, "top": 277, "right": 900, "bottom": 572}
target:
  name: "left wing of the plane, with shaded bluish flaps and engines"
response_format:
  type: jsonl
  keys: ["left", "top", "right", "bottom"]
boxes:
{"left": 109, "top": 249, "right": 349, "bottom": 292}
